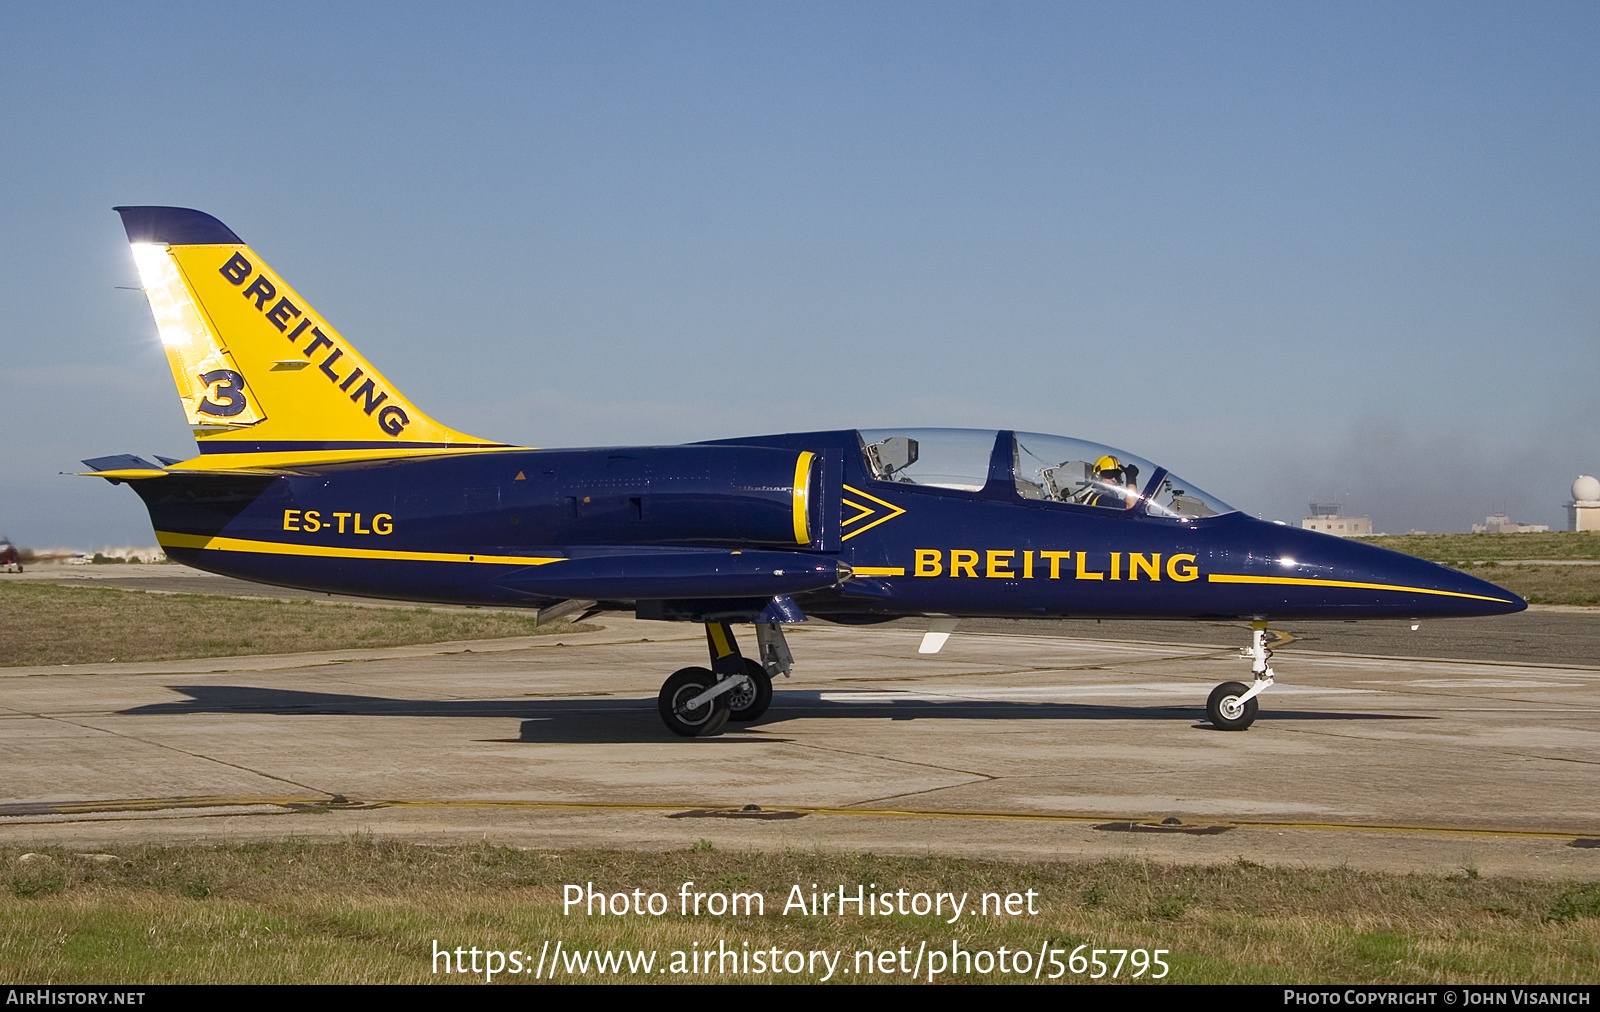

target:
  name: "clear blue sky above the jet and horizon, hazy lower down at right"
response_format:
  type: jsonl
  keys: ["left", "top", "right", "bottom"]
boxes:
{"left": 0, "top": 3, "right": 1600, "bottom": 548}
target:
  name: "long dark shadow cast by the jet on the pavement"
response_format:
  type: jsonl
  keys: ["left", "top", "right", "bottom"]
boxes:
{"left": 120, "top": 685, "right": 1435, "bottom": 745}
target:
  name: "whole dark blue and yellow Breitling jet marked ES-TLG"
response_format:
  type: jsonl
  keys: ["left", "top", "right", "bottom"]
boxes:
{"left": 85, "top": 207, "right": 1526, "bottom": 737}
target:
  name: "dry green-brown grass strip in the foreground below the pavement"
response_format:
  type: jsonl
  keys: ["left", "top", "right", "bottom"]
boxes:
{"left": 0, "top": 837, "right": 1600, "bottom": 983}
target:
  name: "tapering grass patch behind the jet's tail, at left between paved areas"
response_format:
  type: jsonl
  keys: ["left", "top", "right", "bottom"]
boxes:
{"left": 0, "top": 583, "right": 592, "bottom": 668}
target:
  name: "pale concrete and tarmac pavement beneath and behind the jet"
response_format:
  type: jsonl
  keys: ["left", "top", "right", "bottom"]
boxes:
{"left": 0, "top": 565, "right": 1600, "bottom": 877}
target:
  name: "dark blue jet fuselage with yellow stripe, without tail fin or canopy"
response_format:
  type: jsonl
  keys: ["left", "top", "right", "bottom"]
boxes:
{"left": 131, "top": 431, "right": 1526, "bottom": 621}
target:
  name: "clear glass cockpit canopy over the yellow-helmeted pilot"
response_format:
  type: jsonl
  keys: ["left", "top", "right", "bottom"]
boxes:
{"left": 859, "top": 429, "right": 1237, "bottom": 520}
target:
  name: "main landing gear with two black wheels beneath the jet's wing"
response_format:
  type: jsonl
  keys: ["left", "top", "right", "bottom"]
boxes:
{"left": 656, "top": 621, "right": 794, "bottom": 738}
